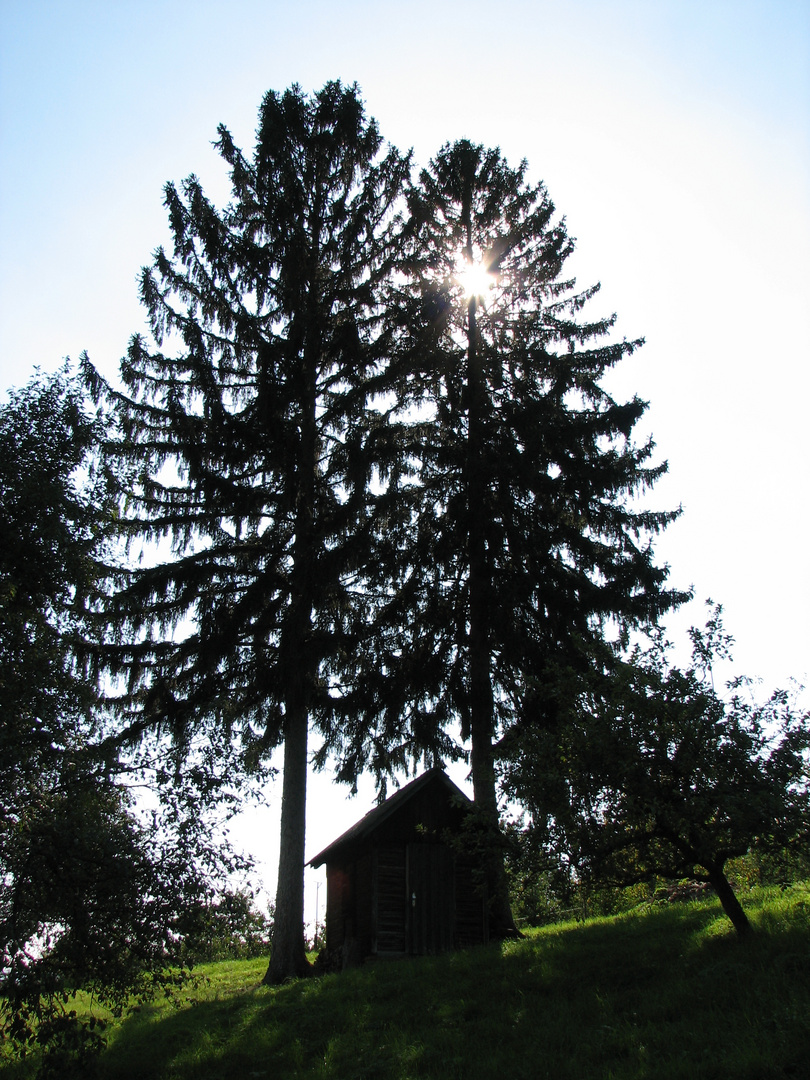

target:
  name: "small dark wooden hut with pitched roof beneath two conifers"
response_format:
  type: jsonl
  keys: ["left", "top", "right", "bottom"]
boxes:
{"left": 310, "top": 769, "right": 488, "bottom": 960}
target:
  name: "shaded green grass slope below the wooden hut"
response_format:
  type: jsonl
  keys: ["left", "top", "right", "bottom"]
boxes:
{"left": 3, "top": 883, "right": 810, "bottom": 1080}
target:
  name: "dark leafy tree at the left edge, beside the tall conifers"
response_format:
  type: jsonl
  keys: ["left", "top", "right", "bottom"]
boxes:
{"left": 0, "top": 369, "right": 240, "bottom": 1076}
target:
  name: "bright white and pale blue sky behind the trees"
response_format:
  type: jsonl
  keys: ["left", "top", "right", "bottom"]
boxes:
{"left": 0, "top": 0, "right": 810, "bottom": 918}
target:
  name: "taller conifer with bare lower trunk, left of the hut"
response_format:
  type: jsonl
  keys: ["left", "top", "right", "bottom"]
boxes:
{"left": 87, "top": 83, "right": 408, "bottom": 981}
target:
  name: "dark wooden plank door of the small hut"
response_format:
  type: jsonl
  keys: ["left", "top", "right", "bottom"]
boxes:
{"left": 407, "top": 843, "right": 455, "bottom": 956}
